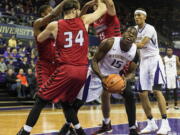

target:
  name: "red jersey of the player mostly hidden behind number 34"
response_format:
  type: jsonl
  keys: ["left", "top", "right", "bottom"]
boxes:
{"left": 36, "top": 37, "right": 55, "bottom": 62}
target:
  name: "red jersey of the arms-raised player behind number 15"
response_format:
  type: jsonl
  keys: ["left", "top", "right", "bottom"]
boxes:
{"left": 93, "top": 13, "right": 121, "bottom": 41}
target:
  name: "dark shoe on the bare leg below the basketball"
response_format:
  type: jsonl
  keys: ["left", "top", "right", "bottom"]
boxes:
{"left": 92, "top": 121, "right": 112, "bottom": 135}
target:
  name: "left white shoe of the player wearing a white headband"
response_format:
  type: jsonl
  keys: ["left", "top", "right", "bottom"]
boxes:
{"left": 140, "top": 119, "right": 158, "bottom": 134}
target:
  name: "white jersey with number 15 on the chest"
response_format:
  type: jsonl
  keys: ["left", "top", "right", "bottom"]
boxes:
{"left": 98, "top": 37, "right": 137, "bottom": 75}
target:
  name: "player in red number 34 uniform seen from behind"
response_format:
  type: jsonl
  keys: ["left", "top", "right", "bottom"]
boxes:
{"left": 16, "top": 0, "right": 106, "bottom": 135}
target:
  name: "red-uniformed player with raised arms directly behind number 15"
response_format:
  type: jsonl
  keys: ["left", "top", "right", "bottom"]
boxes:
{"left": 81, "top": 0, "right": 121, "bottom": 134}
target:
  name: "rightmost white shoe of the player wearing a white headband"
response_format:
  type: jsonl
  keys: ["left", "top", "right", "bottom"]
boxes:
{"left": 157, "top": 119, "right": 171, "bottom": 135}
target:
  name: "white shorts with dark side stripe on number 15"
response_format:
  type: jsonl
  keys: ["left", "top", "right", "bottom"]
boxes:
{"left": 77, "top": 68, "right": 103, "bottom": 102}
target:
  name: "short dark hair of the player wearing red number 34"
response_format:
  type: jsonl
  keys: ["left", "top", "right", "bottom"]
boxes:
{"left": 63, "top": 0, "right": 80, "bottom": 13}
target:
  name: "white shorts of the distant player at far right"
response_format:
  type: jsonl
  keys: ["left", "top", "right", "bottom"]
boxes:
{"left": 166, "top": 74, "right": 176, "bottom": 89}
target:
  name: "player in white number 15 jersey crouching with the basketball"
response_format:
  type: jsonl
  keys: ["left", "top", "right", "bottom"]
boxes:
{"left": 58, "top": 27, "right": 138, "bottom": 135}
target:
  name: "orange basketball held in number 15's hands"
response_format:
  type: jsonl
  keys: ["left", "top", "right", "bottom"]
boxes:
{"left": 105, "top": 74, "right": 125, "bottom": 93}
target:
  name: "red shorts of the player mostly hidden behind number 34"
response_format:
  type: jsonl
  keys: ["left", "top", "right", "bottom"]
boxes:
{"left": 36, "top": 60, "right": 57, "bottom": 88}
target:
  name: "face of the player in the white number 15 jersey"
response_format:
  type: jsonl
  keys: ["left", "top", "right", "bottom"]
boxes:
{"left": 123, "top": 28, "right": 137, "bottom": 44}
